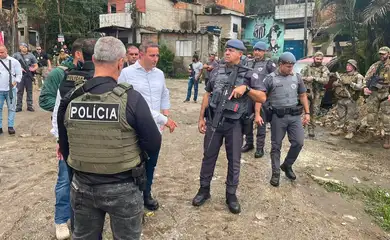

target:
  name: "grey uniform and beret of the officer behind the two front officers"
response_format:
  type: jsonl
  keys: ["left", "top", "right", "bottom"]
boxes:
{"left": 242, "top": 42, "right": 276, "bottom": 158}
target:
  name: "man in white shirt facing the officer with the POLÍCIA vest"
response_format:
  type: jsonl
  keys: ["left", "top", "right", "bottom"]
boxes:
{"left": 118, "top": 43, "right": 177, "bottom": 211}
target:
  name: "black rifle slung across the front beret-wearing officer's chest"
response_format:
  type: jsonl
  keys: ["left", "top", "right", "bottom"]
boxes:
{"left": 206, "top": 65, "right": 238, "bottom": 152}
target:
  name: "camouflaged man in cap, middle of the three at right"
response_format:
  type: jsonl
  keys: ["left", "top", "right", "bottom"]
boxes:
{"left": 331, "top": 59, "right": 364, "bottom": 139}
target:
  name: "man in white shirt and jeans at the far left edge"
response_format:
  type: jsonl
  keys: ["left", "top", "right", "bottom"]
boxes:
{"left": 0, "top": 45, "right": 22, "bottom": 135}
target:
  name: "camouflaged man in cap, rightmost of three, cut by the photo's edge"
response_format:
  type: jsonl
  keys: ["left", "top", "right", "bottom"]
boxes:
{"left": 360, "top": 47, "right": 390, "bottom": 149}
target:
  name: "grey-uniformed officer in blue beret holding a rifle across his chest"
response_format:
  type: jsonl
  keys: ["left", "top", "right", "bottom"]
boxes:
{"left": 192, "top": 40, "right": 266, "bottom": 214}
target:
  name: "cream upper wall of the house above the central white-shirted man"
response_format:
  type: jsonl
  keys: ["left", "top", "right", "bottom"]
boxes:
{"left": 140, "top": 0, "right": 203, "bottom": 30}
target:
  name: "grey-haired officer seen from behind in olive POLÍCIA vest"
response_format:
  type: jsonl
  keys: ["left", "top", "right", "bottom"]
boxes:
{"left": 58, "top": 37, "right": 161, "bottom": 240}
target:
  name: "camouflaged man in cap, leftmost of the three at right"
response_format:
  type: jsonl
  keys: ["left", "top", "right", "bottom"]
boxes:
{"left": 301, "top": 52, "right": 330, "bottom": 137}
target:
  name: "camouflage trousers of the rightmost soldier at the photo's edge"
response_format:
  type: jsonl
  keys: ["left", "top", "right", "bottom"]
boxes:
{"left": 366, "top": 91, "right": 390, "bottom": 135}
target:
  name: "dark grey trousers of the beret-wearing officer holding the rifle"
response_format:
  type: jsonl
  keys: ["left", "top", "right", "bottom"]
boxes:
{"left": 200, "top": 120, "right": 242, "bottom": 194}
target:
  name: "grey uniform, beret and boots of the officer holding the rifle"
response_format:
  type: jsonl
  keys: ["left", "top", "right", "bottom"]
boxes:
{"left": 192, "top": 40, "right": 261, "bottom": 213}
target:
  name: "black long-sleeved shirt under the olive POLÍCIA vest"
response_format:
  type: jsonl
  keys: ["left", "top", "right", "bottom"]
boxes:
{"left": 57, "top": 77, "right": 161, "bottom": 185}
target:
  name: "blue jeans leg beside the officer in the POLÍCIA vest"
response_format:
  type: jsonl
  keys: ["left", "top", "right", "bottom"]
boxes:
{"left": 54, "top": 160, "right": 71, "bottom": 224}
